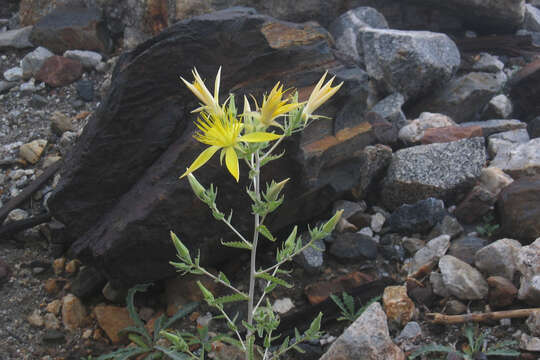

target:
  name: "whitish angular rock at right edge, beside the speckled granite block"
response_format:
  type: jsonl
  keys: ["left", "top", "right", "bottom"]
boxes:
{"left": 490, "top": 138, "right": 540, "bottom": 179}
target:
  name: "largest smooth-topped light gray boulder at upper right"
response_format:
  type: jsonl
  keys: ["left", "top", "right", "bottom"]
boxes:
{"left": 362, "top": 29, "right": 460, "bottom": 100}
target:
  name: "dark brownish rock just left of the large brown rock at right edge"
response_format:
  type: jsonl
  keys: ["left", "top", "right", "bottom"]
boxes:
{"left": 454, "top": 185, "right": 497, "bottom": 224}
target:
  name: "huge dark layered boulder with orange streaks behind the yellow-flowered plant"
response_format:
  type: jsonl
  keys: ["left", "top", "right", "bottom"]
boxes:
{"left": 49, "top": 8, "right": 374, "bottom": 284}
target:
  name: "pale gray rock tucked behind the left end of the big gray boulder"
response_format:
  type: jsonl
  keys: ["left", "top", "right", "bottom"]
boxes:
{"left": 329, "top": 7, "right": 388, "bottom": 63}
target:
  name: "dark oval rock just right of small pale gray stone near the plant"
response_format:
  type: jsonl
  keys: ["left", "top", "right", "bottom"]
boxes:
{"left": 330, "top": 233, "right": 377, "bottom": 260}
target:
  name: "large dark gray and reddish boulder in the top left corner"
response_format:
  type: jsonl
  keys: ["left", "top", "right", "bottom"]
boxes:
{"left": 30, "top": 6, "right": 112, "bottom": 54}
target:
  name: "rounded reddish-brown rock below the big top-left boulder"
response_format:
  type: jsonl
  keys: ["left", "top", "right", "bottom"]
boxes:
{"left": 36, "top": 56, "right": 83, "bottom": 87}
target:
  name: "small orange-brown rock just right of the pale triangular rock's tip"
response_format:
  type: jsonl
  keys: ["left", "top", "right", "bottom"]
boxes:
{"left": 383, "top": 285, "right": 415, "bottom": 326}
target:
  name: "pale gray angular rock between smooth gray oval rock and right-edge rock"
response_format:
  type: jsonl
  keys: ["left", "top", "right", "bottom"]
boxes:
{"left": 474, "top": 239, "right": 521, "bottom": 281}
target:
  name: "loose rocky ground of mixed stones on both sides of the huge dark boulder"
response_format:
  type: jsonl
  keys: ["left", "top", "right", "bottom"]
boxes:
{"left": 0, "top": 2, "right": 540, "bottom": 360}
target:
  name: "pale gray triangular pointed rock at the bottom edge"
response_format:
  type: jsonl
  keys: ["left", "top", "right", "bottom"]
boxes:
{"left": 320, "top": 302, "right": 405, "bottom": 360}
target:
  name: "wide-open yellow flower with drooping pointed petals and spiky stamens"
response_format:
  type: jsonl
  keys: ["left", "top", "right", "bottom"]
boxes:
{"left": 181, "top": 112, "right": 280, "bottom": 181}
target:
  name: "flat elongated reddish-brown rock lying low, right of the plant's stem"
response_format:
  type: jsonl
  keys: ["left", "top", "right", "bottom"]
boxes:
{"left": 304, "top": 271, "right": 374, "bottom": 305}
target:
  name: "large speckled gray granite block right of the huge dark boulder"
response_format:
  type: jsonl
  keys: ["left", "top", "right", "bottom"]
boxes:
{"left": 382, "top": 137, "right": 486, "bottom": 209}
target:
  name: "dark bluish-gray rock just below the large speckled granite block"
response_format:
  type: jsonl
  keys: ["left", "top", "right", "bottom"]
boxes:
{"left": 388, "top": 198, "right": 446, "bottom": 234}
